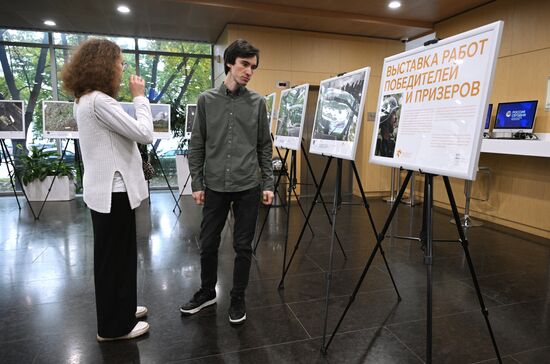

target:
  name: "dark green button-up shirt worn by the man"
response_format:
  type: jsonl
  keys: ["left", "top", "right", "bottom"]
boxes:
{"left": 189, "top": 83, "right": 273, "bottom": 192}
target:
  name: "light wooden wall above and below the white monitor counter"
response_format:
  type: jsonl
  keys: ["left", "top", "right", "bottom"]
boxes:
{"left": 435, "top": 0, "right": 550, "bottom": 238}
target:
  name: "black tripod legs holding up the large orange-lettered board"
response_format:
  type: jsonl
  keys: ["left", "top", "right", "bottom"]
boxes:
{"left": 322, "top": 171, "right": 502, "bottom": 363}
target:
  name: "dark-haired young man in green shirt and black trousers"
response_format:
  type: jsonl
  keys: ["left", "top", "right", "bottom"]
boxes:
{"left": 180, "top": 39, "right": 273, "bottom": 324}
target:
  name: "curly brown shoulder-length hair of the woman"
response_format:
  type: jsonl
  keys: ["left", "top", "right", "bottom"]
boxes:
{"left": 61, "top": 39, "right": 122, "bottom": 100}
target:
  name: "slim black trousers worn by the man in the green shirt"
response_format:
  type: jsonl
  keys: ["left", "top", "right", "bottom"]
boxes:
{"left": 200, "top": 186, "right": 260, "bottom": 297}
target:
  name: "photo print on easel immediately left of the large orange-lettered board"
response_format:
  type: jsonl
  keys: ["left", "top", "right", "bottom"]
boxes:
{"left": 309, "top": 67, "right": 370, "bottom": 160}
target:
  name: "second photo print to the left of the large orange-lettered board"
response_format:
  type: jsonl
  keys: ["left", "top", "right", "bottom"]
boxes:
{"left": 273, "top": 84, "right": 309, "bottom": 150}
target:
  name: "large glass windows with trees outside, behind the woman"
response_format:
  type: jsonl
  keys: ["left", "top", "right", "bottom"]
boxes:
{"left": 0, "top": 29, "right": 212, "bottom": 194}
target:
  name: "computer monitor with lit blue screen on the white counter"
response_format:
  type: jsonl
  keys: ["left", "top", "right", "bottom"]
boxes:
{"left": 493, "top": 100, "right": 538, "bottom": 134}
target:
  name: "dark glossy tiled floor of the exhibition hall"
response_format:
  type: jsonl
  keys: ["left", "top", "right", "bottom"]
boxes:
{"left": 0, "top": 192, "right": 550, "bottom": 364}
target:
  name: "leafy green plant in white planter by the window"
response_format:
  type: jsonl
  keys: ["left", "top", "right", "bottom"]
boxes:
{"left": 16, "top": 144, "right": 75, "bottom": 201}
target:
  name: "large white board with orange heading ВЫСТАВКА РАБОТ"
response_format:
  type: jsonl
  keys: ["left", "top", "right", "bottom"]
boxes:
{"left": 370, "top": 21, "right": 503, "bottom": 179}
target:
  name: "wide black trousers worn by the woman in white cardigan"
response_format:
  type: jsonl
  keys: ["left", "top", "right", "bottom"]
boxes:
{"left": 91, "top": 192, "right": 137, "bottom": 337}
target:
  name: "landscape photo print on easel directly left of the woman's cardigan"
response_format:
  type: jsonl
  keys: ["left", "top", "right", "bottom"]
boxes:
{"left": 42, "top": 101, "right": 78, "bottom": 139}
